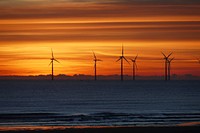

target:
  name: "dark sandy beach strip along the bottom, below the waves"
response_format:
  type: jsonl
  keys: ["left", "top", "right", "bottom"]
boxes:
{"left": 0, "top": 126, "right": 200, "bottom": 133}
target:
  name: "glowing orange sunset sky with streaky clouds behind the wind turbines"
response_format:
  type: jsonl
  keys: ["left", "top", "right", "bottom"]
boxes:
{"left": 0, "top": 0, "right": 200, "bottom": 76}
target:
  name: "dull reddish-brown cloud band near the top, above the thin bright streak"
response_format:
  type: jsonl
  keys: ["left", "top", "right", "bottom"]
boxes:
{"left": 0, "top": 1, "right": 200, "bottom": 19}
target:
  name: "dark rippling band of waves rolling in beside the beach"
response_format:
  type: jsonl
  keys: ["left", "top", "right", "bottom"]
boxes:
{"left": 0, "top": 112, "right": 200, "bottom": 126}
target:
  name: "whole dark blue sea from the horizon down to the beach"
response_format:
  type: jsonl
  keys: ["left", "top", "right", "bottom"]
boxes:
{"left": 0, "top": 80, "right": 200, "bottom": 126}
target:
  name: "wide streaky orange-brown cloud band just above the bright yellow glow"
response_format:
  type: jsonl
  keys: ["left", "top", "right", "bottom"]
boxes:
{"left": 0, "top": 21, "right": 200, "bottom": 42}
